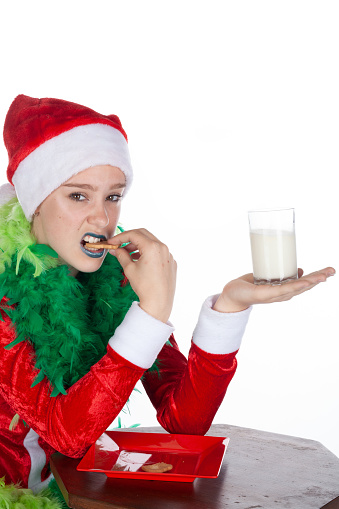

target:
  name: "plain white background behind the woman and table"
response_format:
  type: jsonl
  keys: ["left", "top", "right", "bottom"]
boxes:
{"left": 0, "top": 0, "right": 339, "bottom": 455}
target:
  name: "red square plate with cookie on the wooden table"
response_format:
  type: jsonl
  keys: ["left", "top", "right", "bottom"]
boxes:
{"left": 77, "top": 431, "right": 229, "bottom": 482}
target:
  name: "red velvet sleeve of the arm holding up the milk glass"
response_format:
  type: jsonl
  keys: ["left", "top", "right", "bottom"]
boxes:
{"left": 142, "top": 336, "right": 237, "bottom": 435}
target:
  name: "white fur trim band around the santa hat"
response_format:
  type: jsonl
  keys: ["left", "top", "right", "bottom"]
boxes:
{"left": 13, "top": 124, "right": 133, "bottom": 221}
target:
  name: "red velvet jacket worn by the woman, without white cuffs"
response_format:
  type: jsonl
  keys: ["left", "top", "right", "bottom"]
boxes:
{"left": 0, "top": 300, "right": 236, "bottom": 488}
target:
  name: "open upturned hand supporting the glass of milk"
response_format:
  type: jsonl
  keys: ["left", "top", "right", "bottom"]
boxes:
{"left": 213, "top": 267, "right": 335, "bottom": 313}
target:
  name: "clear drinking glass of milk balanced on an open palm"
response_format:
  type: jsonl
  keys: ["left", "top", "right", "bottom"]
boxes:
{"left": 248, "top": 209, "right": 298, "bottom": 285}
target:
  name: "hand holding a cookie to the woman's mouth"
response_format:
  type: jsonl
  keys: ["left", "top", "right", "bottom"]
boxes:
{"left": 109, "top": 228, "right": 177, "bottom": 323}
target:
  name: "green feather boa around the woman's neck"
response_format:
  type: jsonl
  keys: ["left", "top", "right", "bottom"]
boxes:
{"left": 0, "top": 199, "right": 138, "bottom": 396}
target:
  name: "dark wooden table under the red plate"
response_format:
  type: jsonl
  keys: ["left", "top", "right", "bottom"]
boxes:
{"left": 51, "top": 424, "right": 339, "bottom": 509}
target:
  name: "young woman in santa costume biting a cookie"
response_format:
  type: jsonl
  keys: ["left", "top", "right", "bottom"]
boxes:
{"left": 0, "top": 95, "right": 334, "bottom": 500}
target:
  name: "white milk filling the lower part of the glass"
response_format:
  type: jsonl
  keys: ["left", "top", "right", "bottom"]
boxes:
{"left": 250, "top": 230, "right": 298, "bottom": 283}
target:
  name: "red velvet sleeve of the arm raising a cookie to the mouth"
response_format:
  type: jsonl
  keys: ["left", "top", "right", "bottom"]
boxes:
{"left": 0, "top": 308, "right": 144, "bottom": 457}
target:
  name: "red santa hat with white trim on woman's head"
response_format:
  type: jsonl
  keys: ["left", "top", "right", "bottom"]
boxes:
{"left": 0, "top": 95, "right": 133, "bottom": 221}
